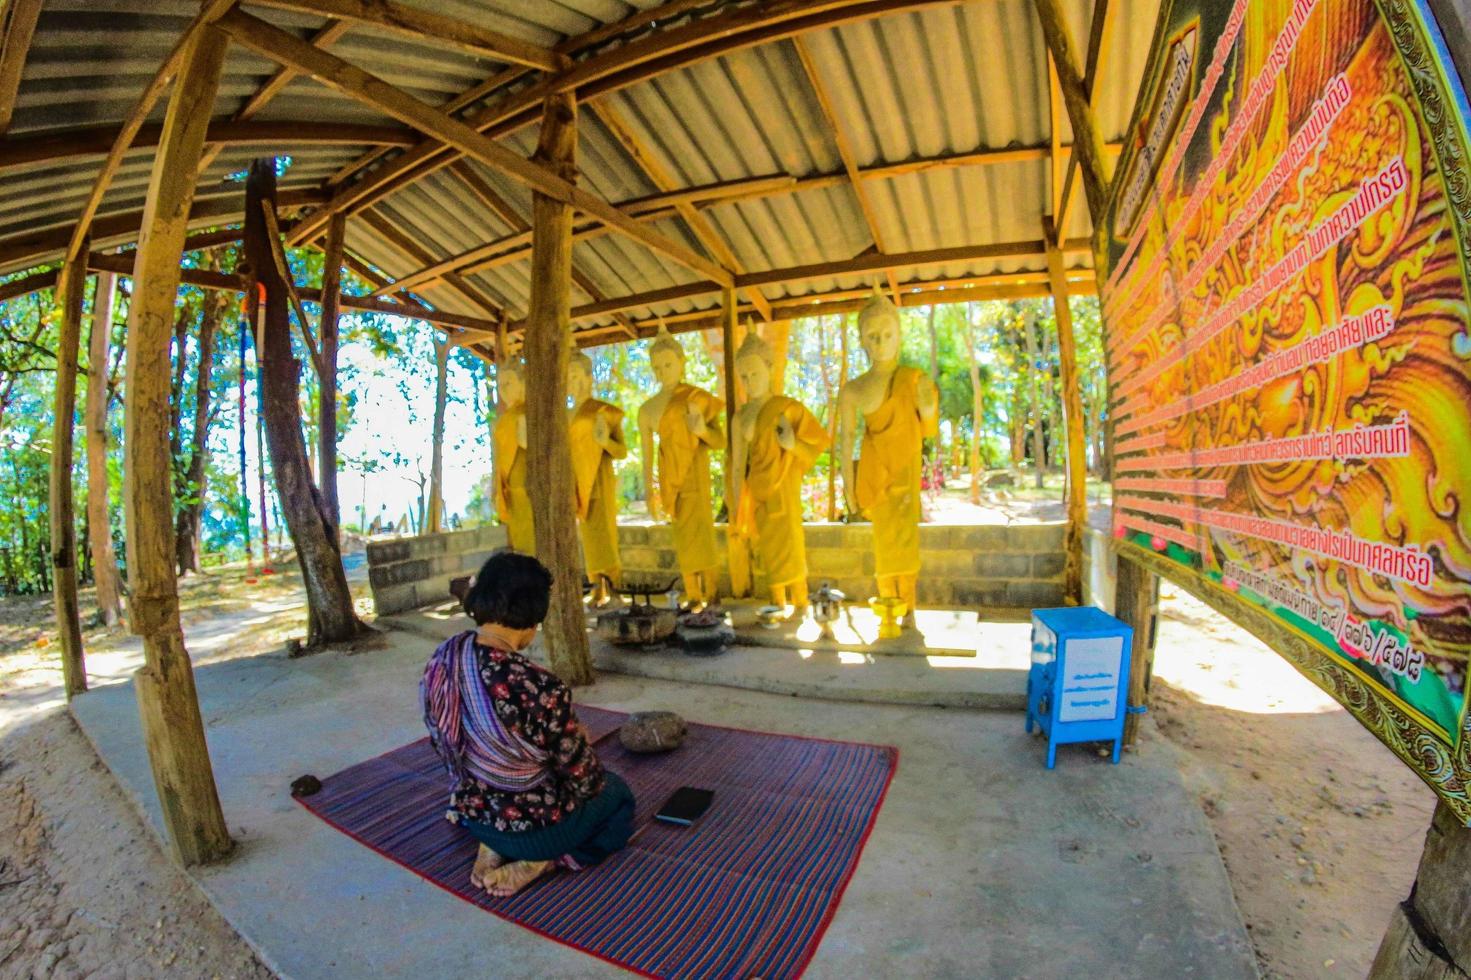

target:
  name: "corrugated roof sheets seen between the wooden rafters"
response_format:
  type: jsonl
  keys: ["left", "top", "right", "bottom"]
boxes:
{"left": 0, "top": 0, "right": 1158, "bottom": 332}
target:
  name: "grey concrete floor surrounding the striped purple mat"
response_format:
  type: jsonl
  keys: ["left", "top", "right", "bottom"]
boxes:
{"left": 72, "top": 633, "right": 1256, "bottom": 980}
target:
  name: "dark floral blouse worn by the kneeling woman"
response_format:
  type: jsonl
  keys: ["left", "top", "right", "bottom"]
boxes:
{"left": 446, "top": 643, "right": 603, "bottom": 833}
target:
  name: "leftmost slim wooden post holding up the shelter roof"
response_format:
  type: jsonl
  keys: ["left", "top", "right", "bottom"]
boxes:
{"left": 50, "top": 250, "right": 87, "bottom": 699}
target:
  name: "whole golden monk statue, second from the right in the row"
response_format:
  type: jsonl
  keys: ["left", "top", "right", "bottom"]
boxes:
{"left": 730, "top": 333, "right": 828, "bottom": 618}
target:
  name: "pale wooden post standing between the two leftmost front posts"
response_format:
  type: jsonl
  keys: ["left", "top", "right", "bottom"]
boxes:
{"left": 82, "top": 264, "right": 122, "bottom": 627}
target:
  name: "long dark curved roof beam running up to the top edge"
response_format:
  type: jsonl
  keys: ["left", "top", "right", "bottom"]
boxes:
{"left": 280, "top": 0, "right": 958, "bottom": 248}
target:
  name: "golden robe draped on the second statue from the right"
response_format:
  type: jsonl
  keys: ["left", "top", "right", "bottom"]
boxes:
{"left": 737, "top": 394, "right": 830, "bottom": 588}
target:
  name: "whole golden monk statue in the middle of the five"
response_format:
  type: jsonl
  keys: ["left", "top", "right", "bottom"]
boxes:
{"left": 638, "top": 331, "right": 725, "bottom": 611}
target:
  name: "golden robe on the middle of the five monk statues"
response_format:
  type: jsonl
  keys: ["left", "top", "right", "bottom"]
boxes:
{"left": 658, "top": 384, "right": 725, "bottom": 575}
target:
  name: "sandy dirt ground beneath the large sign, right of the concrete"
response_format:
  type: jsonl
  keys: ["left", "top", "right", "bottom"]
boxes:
{"left": 1150, "top": 586, "right": 1434, "bottom": 977}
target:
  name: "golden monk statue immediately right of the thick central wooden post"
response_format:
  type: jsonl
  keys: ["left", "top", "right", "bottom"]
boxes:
{"left": 566, "top": 353, "right": 628, "bottom": 605}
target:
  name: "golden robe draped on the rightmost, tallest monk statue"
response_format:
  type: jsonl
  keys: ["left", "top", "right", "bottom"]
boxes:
{"left": 855, "top": 366, "right": 940, "bottom": 575}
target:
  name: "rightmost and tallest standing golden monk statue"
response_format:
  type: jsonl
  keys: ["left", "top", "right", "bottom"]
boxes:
{"left": 837, "top": 294, "right": 940, "bottom": 625}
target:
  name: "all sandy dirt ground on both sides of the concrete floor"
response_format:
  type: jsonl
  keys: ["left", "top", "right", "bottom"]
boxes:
{"left": 0, "top": 550, "right": 1434, "bottom": 979}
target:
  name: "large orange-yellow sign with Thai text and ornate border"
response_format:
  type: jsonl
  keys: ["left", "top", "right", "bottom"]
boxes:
{"left": 1103, "top": 0, "right": 1471, "bottom": 820}
